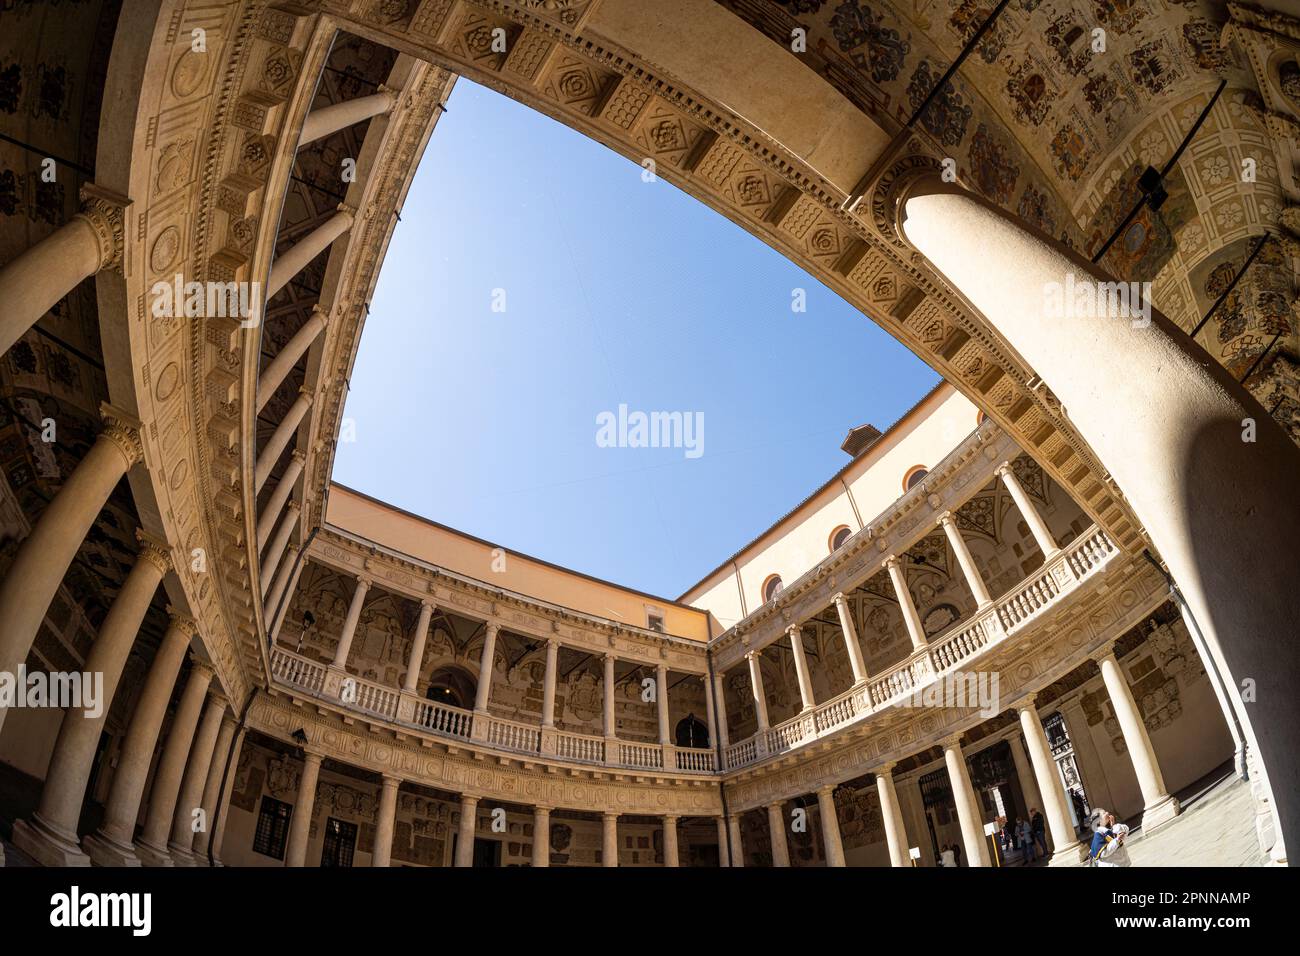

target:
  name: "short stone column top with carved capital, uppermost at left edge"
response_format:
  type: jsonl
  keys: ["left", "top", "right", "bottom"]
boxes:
{"left": 0, "top": 186, "right": 130, "bottom": 355}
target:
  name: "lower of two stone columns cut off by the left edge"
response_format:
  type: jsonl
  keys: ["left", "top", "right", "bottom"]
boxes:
{"left": 0, "top": 408, "right": 143, "bottom": 728}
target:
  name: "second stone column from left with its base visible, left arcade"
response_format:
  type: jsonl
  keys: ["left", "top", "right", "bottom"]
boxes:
{"left": 82, "top": 607, "right": 196, "bottom": 866}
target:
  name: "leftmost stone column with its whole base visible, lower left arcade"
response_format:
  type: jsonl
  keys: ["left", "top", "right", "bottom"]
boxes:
{"left": 13, "top": 531, "right": 170, "bottom": 866}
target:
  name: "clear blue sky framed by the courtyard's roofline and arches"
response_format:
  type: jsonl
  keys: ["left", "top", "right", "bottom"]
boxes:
{"left": 334, "top": 79, "right": 937, "bottom": 606}
